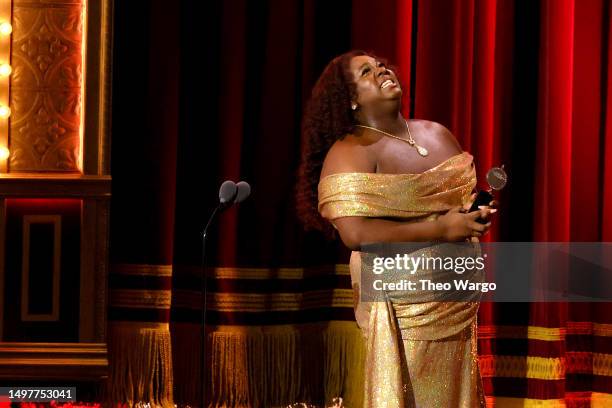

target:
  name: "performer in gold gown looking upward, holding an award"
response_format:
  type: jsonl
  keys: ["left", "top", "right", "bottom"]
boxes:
{"left": 298, "top": 51, "right": 495, "bottom": 408}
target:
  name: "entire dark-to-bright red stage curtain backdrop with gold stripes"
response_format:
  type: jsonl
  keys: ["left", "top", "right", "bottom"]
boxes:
{"left": 111, "top": 0, "right": 612, "bottom": 406}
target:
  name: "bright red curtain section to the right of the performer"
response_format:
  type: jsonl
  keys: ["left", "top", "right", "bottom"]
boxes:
{"left": 412, "top": 0, "right": 612, "bottom": 406}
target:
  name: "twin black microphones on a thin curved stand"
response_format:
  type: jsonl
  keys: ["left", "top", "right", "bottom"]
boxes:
{"left": 200, "top": 180, "right": 251, "bottom": 408}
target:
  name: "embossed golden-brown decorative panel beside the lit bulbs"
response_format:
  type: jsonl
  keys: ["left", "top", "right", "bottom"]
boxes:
{"left": 9, "top": 0, "right": 84, "bottom": 172}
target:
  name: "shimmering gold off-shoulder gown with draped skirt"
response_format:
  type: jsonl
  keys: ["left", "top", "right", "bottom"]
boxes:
{"left": 319, "top": 152, "right": 485, "bottom": 408}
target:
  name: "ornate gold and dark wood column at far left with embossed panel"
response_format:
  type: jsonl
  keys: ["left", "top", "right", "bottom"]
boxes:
{"left": 0, "top": 0, "right": 112, "bottom": 381}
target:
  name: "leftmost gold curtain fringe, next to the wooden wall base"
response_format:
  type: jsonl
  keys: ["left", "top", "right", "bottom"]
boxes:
{"left": 107, "top": 322, "right": 174, "bottom": 408}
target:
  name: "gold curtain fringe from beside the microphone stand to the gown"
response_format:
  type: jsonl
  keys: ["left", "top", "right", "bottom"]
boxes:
{"left": 173, "top": 321, "right": 365, "bottom": 407}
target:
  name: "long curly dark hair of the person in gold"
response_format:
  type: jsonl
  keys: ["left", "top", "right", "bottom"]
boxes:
{"left": 296, "top": 50, "right": 373, "bottom": 237}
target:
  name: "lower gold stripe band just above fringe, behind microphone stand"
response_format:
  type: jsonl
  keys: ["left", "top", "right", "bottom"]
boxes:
{"left": 173, "top": 289, "right": 353, "bottom": 312}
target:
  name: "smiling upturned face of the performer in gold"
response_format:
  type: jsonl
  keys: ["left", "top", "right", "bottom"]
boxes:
{"left": 350, "top": 55, "right": 402, "bottom": 108}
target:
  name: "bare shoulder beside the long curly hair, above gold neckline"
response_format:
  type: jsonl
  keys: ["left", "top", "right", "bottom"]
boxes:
{"left": 321, "top": 135, "right": 376, "bottom": 178}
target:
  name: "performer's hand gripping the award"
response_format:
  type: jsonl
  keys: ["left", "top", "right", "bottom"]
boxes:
{"left": 437, "top": 206, "right": 494, "bottom": 242}
